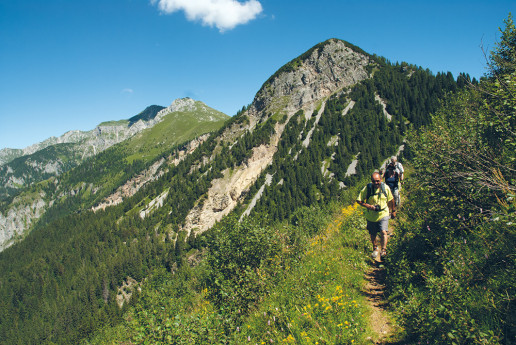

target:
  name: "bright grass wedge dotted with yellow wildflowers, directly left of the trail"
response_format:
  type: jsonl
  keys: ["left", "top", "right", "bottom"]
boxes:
{"left": 235, "top": 206, "right": 370, "bottom": 344}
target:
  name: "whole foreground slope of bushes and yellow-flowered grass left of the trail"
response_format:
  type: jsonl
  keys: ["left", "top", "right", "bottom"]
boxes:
{"left": 85, "top": 185, "right": 400, "bottom": 344}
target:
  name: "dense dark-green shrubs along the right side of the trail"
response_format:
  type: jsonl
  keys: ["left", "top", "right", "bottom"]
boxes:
{"left": 387, "top": 17, "right": 516, "bottom": 344}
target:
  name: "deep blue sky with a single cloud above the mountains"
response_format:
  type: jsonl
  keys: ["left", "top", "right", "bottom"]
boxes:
{"left": 0, "top": 0, "right": 516, "bottom": 148}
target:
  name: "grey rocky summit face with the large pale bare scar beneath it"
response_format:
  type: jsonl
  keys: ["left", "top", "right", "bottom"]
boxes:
{"left": 177, "top": 39, "right": 374, "bottom": 233}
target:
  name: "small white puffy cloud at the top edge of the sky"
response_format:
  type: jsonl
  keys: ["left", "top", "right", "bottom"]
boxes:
{"left": 151, "top": 0, "right": 262, "bottom": 32}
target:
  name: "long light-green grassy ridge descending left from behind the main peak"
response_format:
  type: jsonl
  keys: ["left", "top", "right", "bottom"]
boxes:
{"left": 0, "top": 101, "right": 228, "bottom": 251}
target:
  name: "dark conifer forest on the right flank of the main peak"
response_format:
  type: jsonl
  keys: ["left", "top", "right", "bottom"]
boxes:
{"left": 249, "top": 59, "right": 471, "bottom": 220}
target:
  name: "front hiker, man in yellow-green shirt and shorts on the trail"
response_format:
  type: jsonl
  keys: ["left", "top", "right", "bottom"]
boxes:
{"left": 356, "top": 172, "right": 396, "bottom": 259}
